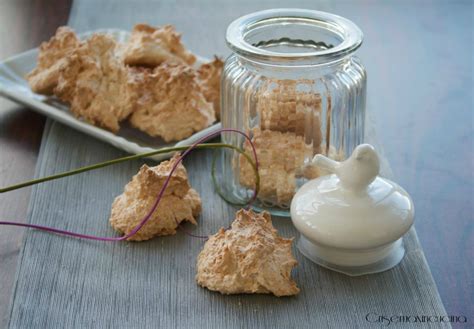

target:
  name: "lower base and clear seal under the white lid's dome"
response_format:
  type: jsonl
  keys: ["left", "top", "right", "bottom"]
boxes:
{"left": 298, "top": 236, "right": 405, "bottom": 276}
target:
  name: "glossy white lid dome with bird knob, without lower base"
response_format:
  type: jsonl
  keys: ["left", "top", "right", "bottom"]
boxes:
{"left": 291, "top": 144, "right": 414, "bottom": 249}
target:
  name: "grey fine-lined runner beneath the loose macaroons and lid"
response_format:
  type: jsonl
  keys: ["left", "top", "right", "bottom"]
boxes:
{"left": 10, "top": 123, "right": 449, "bottom": 328}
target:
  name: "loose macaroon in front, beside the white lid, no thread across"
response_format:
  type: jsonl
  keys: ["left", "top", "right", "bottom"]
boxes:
{"left": 196, "top": 209, "right": 300, "bottom": 296}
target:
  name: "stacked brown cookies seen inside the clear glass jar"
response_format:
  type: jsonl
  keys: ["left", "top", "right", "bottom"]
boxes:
{"left": 238, "top": 79, "right": 344, "bottom": 209}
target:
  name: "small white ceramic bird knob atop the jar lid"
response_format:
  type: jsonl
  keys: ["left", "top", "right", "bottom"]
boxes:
{"left": 313, "top": 144, "right": 380, "bottom": 190}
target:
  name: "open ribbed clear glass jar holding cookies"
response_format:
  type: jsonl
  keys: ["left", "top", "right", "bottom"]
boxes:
{"left": 221, "top": 9, "right": 366, "bottom": 216}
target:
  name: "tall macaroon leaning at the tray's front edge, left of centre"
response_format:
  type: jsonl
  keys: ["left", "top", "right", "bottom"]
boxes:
{"left": 54, "top": 34, "right": 135, "bottom": 132}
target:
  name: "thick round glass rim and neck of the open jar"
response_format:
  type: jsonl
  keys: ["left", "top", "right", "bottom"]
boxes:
{"left": 227, "top": 9, "right": 363, "bottom": 67}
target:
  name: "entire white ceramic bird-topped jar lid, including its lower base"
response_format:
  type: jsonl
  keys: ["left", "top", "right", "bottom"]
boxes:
{"left": 291, "top": 144, "right": 414, "bottom": 275}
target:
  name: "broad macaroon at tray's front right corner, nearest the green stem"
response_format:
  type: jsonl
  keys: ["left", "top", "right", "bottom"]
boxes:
{"left": 130, "top": 63, "right": 216, "bottom": 142}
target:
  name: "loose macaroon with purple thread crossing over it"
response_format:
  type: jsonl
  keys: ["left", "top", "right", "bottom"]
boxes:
{"left": 109, "top": 155, "right": 201, "bottom": 241}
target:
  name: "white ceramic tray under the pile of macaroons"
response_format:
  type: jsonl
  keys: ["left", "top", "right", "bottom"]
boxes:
{"left": 0, "top": 29, "right": 220, "bottom": 160}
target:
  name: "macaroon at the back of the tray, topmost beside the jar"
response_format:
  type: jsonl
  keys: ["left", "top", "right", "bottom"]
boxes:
{"left": 123, "top": 24, "right": 196, "bottom": 67}
